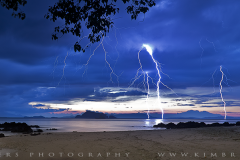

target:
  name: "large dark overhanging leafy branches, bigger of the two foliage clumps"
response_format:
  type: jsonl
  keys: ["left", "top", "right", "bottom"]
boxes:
{"left": 45, "top": 0, "right": 155, "bottom": 52}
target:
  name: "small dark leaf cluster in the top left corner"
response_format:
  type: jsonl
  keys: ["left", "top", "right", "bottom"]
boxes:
{"left": 0, "top": 0, "right": 27, "bottom": 20}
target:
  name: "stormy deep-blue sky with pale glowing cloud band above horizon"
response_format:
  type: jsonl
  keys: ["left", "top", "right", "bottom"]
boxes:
{"left": 0, "top": 0, "right": 240, "bottom": 117}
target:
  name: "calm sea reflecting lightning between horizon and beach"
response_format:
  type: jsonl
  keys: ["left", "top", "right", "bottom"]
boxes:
{"left": 0, "top": 118, "right": 240, "bottom": 135}
